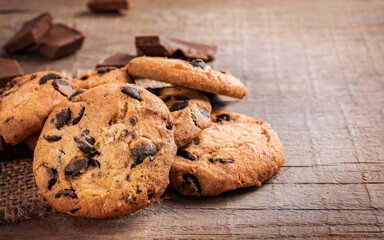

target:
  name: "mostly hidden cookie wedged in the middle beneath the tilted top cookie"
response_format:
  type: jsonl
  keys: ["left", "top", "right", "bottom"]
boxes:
{"left": 158, "top": 87, "right": 212, "bottom": 147}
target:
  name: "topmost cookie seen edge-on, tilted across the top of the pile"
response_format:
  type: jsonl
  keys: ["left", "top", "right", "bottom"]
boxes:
{"left": 127, "top": 57, "right": 247, "bottom": 98}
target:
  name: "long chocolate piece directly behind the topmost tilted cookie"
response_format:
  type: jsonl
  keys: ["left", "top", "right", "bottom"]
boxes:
{"left": 135, "top": 35, "right": 217, "bottom": 62}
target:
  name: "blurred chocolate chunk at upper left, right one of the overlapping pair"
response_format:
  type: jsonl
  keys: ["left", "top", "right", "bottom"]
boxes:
{"left": 40, "top": 23, "right": 85, "bottom": 59}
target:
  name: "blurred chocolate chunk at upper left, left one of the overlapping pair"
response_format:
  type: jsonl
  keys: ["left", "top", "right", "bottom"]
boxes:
{"left": 4, "top": 12, "right": 53, "bottom": 54}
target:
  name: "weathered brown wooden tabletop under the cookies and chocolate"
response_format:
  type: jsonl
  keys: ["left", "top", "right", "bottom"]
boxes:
{"left": 0, "top": 0, "right": 384, "bottom": 239}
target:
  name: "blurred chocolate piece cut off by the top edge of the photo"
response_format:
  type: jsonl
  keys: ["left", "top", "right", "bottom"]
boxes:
{"left": 87, "top": 0, "right": 131, "bottom": 12}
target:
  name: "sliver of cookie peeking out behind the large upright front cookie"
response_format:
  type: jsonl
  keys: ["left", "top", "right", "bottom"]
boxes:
{"left": 71, "top": 67, "right": 134, "bottom": 89}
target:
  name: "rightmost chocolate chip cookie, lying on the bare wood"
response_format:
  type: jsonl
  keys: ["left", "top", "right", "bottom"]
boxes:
{"left": 170, "top": 110, "right": 285, "bottom": 196}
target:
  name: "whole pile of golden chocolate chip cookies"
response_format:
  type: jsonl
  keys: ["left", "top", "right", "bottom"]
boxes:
{"left": 0, "top": 56, "right": 284, "bottom": 218}
